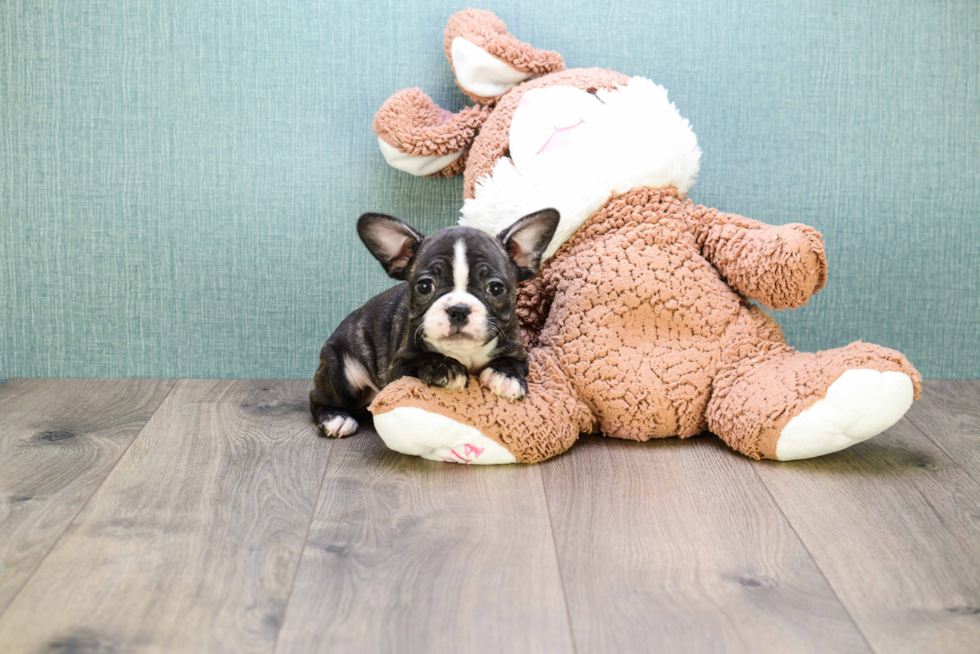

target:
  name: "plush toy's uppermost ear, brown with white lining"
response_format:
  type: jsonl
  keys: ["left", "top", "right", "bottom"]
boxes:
{"left": 442, "top": 9, "right": 565, "bottom": 104}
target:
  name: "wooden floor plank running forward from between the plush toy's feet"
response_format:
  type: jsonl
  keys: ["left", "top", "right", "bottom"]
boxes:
{"left": 541, "top": 436, "right": 868, "bottom": 653}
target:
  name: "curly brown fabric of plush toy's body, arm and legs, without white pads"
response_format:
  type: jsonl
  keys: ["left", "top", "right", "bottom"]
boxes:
{"left": 371, "top": 188, "right": 920, "bottom": 463}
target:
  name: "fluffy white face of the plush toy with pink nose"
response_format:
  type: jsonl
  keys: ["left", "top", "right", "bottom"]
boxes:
{"left": 460, "top": 82, "right": 701, "bottom": 264}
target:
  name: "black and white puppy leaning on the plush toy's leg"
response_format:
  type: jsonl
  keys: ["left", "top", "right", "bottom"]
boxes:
{"left": 310, "top": 209, "right": 558, "bottom": 437}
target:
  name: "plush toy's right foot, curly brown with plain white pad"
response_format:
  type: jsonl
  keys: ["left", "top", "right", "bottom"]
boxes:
{"left": 705, "top": 338, "right": 921, "bottom": 461}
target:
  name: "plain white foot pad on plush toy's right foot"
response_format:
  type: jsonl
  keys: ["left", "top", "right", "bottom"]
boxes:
{"left": 776, "top": 368, "right": 913, "bottom": 461}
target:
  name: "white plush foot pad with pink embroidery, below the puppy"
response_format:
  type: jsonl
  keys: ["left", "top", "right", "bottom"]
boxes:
{"left": 374, "top": 406, "right": 517, "bottom": 465}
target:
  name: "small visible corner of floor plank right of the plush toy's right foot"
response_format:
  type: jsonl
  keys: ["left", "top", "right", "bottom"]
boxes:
{"left": 909, "top": 379, "right": 980, "bottom": 481}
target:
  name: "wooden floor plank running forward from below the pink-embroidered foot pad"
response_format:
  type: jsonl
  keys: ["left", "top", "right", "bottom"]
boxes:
{"left": 277, "top": 426, "right": 572, "bottom": 654}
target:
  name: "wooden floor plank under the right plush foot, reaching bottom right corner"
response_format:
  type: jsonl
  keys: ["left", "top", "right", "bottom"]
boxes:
{"left": 755, "top": 418, "right": 980, "bottom": 654}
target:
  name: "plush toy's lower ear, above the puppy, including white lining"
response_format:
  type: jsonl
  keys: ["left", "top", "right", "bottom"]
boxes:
{"left": 373, "top": 88, "right": 490, "bottom": 177}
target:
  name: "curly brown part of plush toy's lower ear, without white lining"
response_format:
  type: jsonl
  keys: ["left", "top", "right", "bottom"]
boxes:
{"left": 372, "top": 88, "right": 491, "bottom": 177}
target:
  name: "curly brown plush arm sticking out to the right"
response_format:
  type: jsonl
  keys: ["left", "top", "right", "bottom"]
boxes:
{"left": 692, "top": 206, "right": 827, "bottom": 309}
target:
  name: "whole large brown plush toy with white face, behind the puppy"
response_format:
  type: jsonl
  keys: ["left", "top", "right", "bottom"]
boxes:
{"left": 362, "top": 9, "right": 920, "bottom": 463}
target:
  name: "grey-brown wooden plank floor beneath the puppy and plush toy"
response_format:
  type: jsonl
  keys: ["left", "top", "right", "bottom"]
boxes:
{"left": 0, "top": 379, "right": 980, "bottom": 654}
